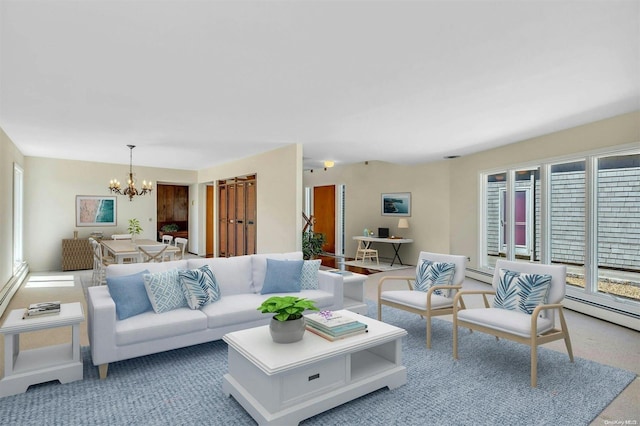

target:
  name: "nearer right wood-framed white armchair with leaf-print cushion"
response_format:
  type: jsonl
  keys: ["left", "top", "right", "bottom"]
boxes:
{"left": 453, "top": 259, "right": 573, "bottom": 387}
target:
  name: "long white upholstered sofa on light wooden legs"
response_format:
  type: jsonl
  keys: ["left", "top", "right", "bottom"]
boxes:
{"left": 87, "top": 252, "right": 343, "bottom": 379}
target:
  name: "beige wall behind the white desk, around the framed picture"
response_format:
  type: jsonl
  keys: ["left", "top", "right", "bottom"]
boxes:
{"left": 304, "top": 160, "right": 451, "bottom": 264}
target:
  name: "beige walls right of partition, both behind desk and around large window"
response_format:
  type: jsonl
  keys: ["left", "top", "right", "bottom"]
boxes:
{"left": 304, "top": 112, "right": 640, "bottom": 268}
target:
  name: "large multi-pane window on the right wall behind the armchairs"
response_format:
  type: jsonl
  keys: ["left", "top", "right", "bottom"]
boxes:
{"left": 480, "top": 149, "right": 640, "bottom": 315}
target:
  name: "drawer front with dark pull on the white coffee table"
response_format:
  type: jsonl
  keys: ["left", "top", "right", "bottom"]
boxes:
{"left": 281, "top": 356, "right": 346, "bottom": 406}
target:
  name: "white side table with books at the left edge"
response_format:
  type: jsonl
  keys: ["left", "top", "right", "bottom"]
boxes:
{"left": 0, "top": 302, "right": 84, "bottom": 397}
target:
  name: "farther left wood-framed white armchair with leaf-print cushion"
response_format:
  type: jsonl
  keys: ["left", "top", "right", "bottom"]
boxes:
{"left": 378, "top": 251, "right": 467, "bottom": 348}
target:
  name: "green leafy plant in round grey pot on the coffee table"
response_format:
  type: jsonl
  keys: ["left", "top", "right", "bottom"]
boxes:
{"left": 257, "top": 296, "right": 319, "bottom": 343}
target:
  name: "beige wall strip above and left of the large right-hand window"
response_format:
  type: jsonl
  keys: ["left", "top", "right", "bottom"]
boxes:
{"left": 450, "top": 112, "right": 640, "bottom": 268}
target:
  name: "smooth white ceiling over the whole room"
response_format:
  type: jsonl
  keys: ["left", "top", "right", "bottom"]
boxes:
{"left": 0, "top": 0, "right": 640, "bottom": 170}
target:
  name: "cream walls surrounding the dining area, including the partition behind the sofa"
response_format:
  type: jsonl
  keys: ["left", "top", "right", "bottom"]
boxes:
{"left": 10, "top": 139, "right": 302, "bottom": 272}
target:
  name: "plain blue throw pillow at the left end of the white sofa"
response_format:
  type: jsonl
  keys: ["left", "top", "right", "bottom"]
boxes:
{"left": 107, "top": 270, "right": 153, "bottom": 320}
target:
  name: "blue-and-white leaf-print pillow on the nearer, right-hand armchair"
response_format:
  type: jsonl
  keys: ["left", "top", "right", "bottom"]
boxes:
{"left": 493, "top": 269, "right": 551, "bottom": 315}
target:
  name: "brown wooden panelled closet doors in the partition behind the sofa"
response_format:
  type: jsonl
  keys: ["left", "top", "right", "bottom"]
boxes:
{"left": 218, "top": 175, "right": 257, "bottom": 257}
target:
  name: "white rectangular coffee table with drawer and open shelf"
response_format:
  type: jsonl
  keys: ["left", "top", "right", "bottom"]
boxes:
{"left": 222, "top": 310, "right": 407, "bottom": 425}
